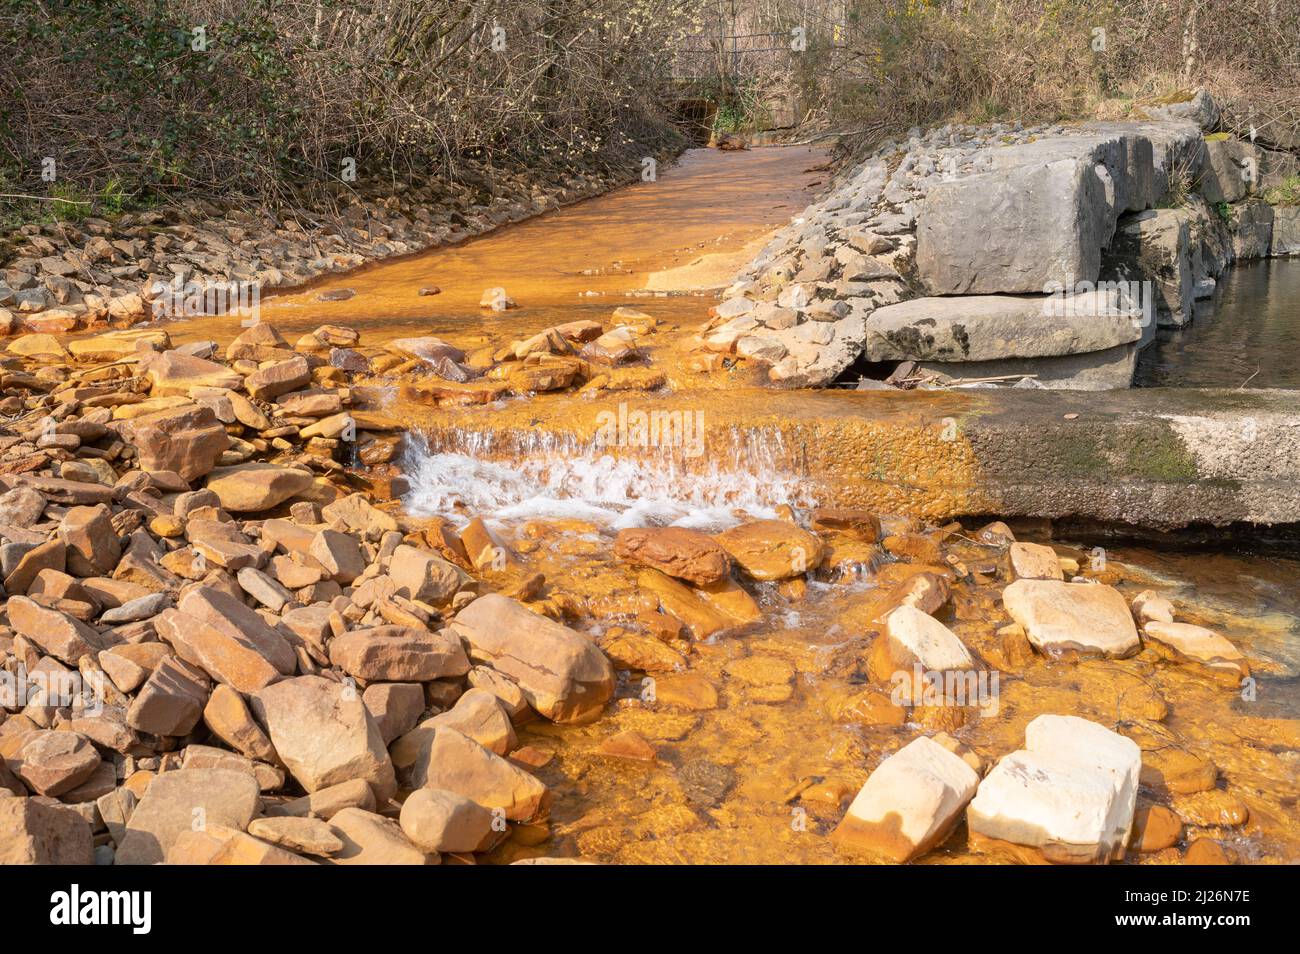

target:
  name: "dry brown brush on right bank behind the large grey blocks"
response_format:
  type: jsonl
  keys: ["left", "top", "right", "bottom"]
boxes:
{"left": 705, "top": 0, "right": 1300, "bottom": 148}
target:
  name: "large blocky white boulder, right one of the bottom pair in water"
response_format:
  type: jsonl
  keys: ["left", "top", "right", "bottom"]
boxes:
{"left": 966, "top": 715, "right": 1141, "bottom": 863}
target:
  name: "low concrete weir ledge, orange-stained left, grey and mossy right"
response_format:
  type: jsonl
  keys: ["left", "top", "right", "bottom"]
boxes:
{"left": 411, "top": 389, "right": 1300, "bottom": 530}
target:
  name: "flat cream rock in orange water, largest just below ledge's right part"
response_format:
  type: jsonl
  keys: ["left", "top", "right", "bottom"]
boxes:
{"left": 1002, "top": 580, "right": 1141, "bottom": 658}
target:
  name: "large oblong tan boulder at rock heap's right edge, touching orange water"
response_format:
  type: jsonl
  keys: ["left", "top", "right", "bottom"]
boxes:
{"left": 455, "top": 593, "right": 614, "bottom": 723}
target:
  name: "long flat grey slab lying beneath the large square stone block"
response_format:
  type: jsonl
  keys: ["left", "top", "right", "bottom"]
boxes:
{"left": 865, "top": 290, "right": 1141, "bottom": 361}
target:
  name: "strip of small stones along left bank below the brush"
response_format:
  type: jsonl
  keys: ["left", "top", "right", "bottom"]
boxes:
{"left": 0, "top": 162, "right": 629, "bottom": 335}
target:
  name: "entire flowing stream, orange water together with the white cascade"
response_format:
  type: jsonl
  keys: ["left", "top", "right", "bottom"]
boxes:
{"left": 162, "top": 148, "right": 1300, "bottom": 863}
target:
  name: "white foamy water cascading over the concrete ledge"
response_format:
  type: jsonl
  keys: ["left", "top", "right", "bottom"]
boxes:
{"left": 406, "top": 432, "right": 816, "bottom": 530}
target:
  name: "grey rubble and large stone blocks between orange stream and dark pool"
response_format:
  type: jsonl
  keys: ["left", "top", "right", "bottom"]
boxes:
{"left": 689, "top": 94, "right": 1300, "bottom": 390}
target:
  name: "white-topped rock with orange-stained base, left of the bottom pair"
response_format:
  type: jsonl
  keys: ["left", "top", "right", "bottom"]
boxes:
{"left": 831, "top": 736, "right": 979, "bottom": 862}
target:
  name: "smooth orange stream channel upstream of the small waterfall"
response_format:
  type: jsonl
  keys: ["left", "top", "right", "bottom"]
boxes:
{"left": 236, "top": 147, "right": 828, "bottom": 346}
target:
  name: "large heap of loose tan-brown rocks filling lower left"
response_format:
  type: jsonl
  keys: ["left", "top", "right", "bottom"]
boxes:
{"left": 0, "top": 325, "right": 614, "bottom": 864}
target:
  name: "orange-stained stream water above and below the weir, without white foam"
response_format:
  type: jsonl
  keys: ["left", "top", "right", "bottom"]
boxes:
{"left": 147, "top": 147, "right": 1300, "bottom": 863}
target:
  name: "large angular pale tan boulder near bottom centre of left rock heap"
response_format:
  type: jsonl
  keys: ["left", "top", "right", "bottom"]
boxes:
{"left": 252, "top": 676, "right": 397, "bottom": 802}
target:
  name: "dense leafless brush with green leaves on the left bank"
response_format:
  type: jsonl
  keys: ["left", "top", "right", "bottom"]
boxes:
{"left": 0, "top": 0, "right": 694, "bottom": 221}
